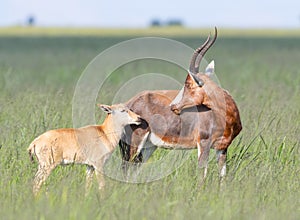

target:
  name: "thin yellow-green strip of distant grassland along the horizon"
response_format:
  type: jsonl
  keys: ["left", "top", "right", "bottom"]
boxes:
{"left": 0, "top": 26, "right": 300, "bottom": 38}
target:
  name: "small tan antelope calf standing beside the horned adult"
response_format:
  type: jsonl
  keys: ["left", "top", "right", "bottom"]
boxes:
{"left": 28, "top": 104, "right": 141, "bottom": 194}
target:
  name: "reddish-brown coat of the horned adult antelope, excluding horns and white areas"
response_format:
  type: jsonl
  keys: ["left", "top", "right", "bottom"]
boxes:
{"left": 120, "top": 76, "right": 242, "bottom": 180}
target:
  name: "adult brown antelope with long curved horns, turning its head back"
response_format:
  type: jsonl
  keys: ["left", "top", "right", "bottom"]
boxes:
{"left": 120, "top": 29, "right": 242, "bottom": 181}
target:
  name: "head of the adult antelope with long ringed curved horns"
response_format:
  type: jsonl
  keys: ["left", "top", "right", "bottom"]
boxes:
{"left": 171, "top": 28, "right": 217, "bottom": 115}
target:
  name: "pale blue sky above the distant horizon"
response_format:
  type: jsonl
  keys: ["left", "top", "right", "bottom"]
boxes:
{"left": 0, "top": 0, "right": 300, "bottom": 28}
